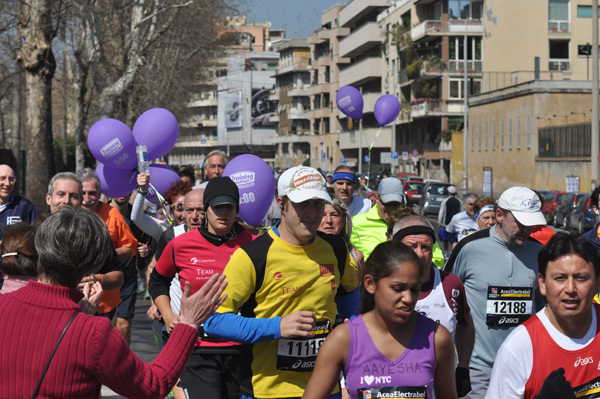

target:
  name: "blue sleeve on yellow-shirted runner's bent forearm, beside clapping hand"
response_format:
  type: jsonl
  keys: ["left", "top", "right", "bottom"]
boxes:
{"left": 204, "top": 313, "right": 281, "bottom": 344}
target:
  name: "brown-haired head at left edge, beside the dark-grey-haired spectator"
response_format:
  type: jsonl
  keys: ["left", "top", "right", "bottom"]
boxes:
{"left": 0, "top": 222, "right": 38, "bottom": 277}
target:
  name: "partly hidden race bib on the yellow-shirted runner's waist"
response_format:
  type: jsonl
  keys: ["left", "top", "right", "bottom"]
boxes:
{"left": 277, "top": 320, "right": 330, "bottom": 371}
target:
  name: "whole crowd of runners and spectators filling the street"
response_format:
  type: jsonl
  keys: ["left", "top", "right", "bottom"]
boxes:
{"left": 0, "top": 151, "right": 600, "bottom": 399}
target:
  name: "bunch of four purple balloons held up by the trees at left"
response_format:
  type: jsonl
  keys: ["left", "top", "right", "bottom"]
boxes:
{"left": 88, "top": 108, "right": 179, "bottom": 204}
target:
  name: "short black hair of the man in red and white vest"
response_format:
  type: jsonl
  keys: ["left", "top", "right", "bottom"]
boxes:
{"left": 538, "top": 232, "right": 600, "bottom": 278}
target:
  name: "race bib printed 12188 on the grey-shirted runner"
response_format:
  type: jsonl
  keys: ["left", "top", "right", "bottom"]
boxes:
{"left": 485, "top": 286, "right": 533, "bottom": 327}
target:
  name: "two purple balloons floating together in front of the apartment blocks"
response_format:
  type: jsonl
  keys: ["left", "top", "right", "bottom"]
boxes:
{"left": 335, "top": 86, "right": 400, "bottom": 126}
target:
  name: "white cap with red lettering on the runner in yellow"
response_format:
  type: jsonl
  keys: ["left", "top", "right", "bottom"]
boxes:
{"left": 277, "top": 166, "right": 331, "bottom": 203}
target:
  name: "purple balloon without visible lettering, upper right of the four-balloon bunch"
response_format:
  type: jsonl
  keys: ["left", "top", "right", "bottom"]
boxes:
{"left": 133, "top": 108, "right": 179, "bottom": 161}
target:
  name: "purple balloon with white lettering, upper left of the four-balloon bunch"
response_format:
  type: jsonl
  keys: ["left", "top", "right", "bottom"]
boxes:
{"left": 88, "top": 118, "right": 137, "bottom": 169}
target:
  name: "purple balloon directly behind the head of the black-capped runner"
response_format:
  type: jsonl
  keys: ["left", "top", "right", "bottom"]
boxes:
{"left": 223, "top": 154, "right": 275, "bottom": 226}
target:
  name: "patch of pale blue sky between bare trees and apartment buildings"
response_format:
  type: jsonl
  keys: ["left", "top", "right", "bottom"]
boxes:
{"left": 246, "top": 0, "right": 350, "bottom": 39}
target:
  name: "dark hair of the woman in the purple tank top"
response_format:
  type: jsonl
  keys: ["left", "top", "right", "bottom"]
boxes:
{"left": 359, "top": 240, "right": 423, "bottom": 314}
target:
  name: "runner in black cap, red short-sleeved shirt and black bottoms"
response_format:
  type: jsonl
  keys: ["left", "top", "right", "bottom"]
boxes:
{"left": 148, "top": 177, "right": 255, "bottom": 399}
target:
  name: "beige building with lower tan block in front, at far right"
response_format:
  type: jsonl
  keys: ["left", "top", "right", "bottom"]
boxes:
{"left": 466, "top": 0, "right": 592, "bottom": 194}
